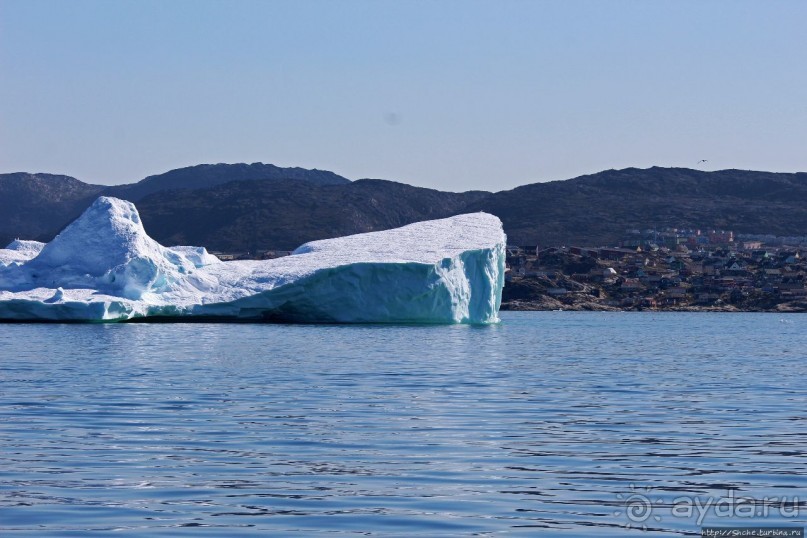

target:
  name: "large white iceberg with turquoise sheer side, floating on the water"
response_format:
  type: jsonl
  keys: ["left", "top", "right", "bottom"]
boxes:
{"left": 0, "top": 197, "right": 506, "bottom": 323}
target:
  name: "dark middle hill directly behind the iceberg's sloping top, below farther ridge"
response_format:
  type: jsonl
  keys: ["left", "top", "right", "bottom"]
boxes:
{"left": 137, "top": 179, "right": 488, "bottom": 252}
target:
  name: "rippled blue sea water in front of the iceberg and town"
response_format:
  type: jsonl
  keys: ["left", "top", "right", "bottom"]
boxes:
{"left": 0, "top": 312, "right": 807, "bottom": 537}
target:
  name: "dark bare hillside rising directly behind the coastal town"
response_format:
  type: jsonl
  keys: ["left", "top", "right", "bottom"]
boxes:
{"left": 465, "top": 167, "right": 807, "bottom": 246}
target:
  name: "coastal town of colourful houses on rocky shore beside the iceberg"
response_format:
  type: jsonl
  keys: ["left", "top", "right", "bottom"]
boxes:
{"left": 502, "top": 228, "right": 807, "bottom": 312}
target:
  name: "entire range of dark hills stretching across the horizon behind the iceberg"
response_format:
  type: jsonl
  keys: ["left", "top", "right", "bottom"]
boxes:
{"left": 0, "top": 163, "right": 807, "bottom": 251}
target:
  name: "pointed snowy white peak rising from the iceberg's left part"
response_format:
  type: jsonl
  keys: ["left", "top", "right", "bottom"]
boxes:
{"left": 26, "top": 196, "right": 196, "bottom": 299}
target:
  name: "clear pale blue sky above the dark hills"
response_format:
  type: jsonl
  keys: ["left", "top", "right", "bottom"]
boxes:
{"left": 0, "top": 0, "right": 807, "bottom": 190}
